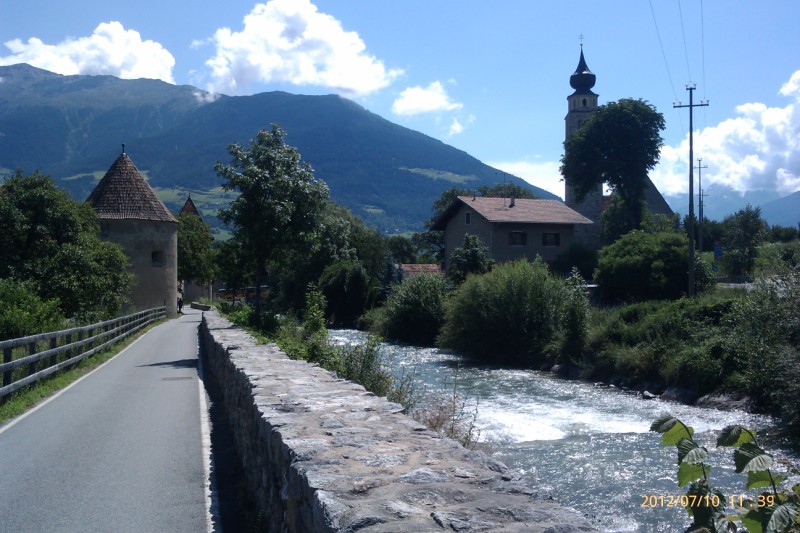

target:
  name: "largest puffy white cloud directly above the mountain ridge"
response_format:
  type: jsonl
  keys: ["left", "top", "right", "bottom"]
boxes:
{"left": 200, "top": 0, "right": 402, "bottom": 96}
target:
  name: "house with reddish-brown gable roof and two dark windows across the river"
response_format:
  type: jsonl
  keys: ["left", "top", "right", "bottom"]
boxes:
{"left": 432, "top": 196, "right": 592, "bottom": 270}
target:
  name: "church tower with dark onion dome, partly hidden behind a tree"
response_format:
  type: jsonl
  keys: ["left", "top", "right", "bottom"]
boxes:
{"left": 564, "top": 45, "right": 603, "bottom": 248}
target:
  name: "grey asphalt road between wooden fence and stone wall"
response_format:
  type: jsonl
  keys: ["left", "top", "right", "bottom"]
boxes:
{"left": 0, "top": 309, "right": 214, "bottom": 533}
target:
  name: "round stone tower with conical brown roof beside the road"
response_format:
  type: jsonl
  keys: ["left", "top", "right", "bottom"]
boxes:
{"left": 86, "top": 145, "right": 178, "bottom": 317}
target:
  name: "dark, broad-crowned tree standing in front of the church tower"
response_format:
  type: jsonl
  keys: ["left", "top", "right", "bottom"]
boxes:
{"left": 561, "top": 98, "right": 664, "bottom": 229}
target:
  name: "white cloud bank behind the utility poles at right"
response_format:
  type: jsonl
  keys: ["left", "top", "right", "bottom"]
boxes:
{"left": 652, "top": 71, "right": 800, "bottom": 195}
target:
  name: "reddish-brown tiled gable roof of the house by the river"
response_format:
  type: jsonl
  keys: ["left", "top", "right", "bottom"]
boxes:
{"left": 434, "top": 196, "right": 592, "bottom": 229}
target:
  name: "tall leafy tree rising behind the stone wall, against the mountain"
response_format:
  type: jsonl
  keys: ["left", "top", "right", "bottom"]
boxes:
{"left": 215, "top": 124, "right": 328, "bottom": 320}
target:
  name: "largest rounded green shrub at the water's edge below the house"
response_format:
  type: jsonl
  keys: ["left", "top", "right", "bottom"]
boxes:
{"left": 439, "top": 258, "right": 564, "bottom": 364}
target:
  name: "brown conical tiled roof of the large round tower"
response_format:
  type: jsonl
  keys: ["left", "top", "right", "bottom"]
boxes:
{"left": 86, "top": 152, "right": 177, "bottom": 222}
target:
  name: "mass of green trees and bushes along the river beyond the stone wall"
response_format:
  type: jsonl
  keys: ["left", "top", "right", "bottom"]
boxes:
{"left": 208, "top": 126, "right": 800, "bottom": 442}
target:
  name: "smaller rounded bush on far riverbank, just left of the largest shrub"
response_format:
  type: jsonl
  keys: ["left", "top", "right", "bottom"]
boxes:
{"left": 383, "top": 273, "right": 445, "bottom": 346}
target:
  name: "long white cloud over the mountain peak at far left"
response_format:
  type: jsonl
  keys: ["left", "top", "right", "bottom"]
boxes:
{"left": 0, "top": 22, "right": 175, "bottom": 83}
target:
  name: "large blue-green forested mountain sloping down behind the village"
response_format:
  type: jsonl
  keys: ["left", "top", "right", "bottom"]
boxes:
{"left": 0, "top": 64, "right": 557, "bottom": 233}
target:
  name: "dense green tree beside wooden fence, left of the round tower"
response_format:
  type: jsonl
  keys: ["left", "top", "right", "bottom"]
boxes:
{"left": 0, "top": 171, "right": 131, "bottom": 321}
